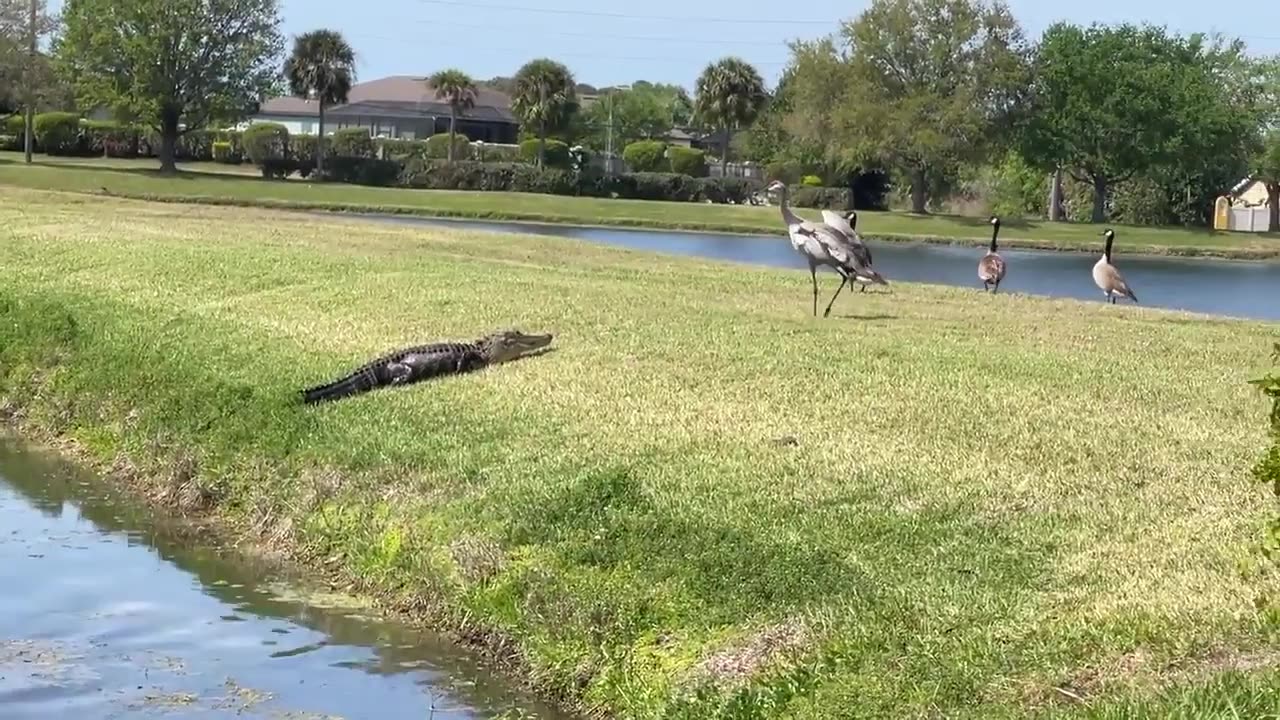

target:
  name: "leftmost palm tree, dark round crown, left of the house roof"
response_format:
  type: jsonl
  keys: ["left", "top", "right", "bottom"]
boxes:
{"left": 284, "top": 29, "right": 356, "bottom": 174}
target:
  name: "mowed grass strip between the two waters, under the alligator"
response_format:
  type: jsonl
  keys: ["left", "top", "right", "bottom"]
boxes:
{"left": 0, "top": 185, "right": 1280, "bottom": 720}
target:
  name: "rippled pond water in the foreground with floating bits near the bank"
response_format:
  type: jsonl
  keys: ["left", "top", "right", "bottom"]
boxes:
{"left": 0, "top": 437, "right": 566, "bottom": 720}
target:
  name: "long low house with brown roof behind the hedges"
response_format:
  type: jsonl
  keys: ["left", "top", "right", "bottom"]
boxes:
{"left": 241, "top": 76, "right": 520, "bottom": 143}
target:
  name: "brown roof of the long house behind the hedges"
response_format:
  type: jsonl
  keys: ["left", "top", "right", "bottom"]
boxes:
{"left": 259, "top": 76, "right": 516, "bottom": 123}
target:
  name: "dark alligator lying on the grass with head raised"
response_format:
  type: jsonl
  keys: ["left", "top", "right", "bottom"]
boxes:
{"left": 302, "top": 329, "right": 552, "bottom": 405}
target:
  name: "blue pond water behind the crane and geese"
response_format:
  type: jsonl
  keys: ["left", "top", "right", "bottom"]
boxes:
{"left": 345, "top": 214, "right": 1280, "bottom": 320}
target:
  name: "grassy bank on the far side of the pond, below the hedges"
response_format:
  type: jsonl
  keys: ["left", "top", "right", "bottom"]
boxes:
{"left": 0, "top": 154, "right": 1280, "bottom": 258}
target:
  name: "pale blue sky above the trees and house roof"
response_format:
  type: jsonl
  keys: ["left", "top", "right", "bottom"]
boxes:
{"left": 40, "top": 0, "right": 1280, "bottom": 90}
